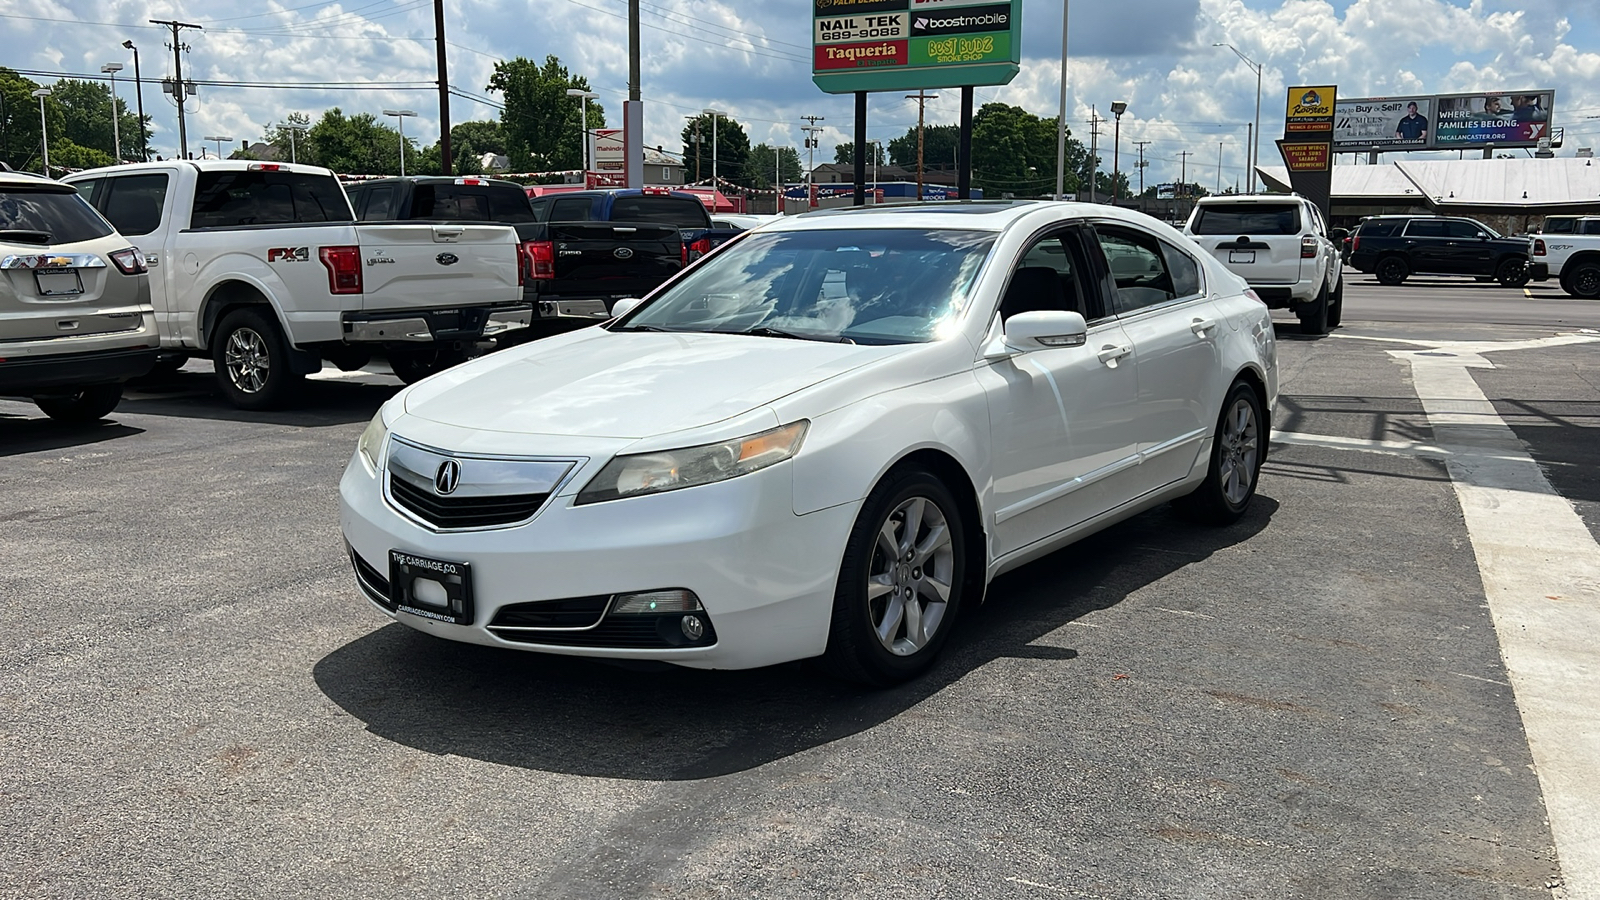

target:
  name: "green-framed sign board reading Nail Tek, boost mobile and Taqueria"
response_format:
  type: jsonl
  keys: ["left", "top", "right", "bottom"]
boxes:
{"left": 811, "top": 0, "right": 1022, "bottom": 94}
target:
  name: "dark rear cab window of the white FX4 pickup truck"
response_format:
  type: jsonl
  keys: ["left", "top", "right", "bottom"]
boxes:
{"left": 189, "top": 170, "right": 355, "bottom": 227}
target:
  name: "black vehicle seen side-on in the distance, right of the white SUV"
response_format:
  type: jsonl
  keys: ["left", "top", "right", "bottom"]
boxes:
{"left": 1349, "top": 216, "right": 1550, "bottom": 288}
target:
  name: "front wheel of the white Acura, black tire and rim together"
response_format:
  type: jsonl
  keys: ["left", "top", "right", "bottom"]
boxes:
{"left": 822, "top": 469, "right": 966, "bottom": 687}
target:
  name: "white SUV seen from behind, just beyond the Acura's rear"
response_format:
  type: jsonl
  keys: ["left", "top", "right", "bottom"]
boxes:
{"left": 1184, "top": 194, "right": 1344, "bottom": 335}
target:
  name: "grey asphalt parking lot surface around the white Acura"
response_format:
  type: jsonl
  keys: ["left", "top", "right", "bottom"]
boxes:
{"left": 0, "top": 279, "right": 1600, "bottom": 898}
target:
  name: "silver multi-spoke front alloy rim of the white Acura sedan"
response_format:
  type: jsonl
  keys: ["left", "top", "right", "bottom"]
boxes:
{"left": 867, "top": 496, "right": 955, "bottom": 657}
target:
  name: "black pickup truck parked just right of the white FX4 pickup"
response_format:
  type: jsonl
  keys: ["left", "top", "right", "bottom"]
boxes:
{"left": 346, "top": 176, "right": 678, "bottom": 344}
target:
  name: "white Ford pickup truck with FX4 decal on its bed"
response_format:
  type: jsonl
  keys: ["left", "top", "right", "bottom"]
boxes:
{"left": 64, "top": 160, "right": 533, "bottom": 410}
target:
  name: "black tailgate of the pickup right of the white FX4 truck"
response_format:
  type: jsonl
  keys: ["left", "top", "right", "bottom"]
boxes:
{"left": 547, "top": 223, "right": 683, "bottom": 298}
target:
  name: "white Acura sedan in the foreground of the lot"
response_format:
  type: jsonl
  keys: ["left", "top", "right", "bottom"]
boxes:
{"left": 339, "top": 202, "right": 1277, "bottom": 684}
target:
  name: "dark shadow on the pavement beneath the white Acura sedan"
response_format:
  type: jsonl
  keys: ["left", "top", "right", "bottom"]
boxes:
{"left": 314, "top": 496, "right": 1278, "bottom": 780}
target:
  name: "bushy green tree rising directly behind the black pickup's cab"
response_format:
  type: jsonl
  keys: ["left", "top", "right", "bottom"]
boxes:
{"left": 483, "top": 56, "right": 605, "bottom": 171}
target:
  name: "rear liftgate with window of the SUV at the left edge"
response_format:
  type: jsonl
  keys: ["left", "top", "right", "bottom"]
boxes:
{"left": 0, "top": 181, "right": 144, "bottom": 341}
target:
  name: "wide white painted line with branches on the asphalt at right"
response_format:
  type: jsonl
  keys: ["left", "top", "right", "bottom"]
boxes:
{"left": 1312, "top": 335, "right": 1600, "bottom": 897}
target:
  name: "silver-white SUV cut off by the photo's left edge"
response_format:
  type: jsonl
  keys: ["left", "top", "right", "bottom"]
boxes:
{"left": 0, "top": 171, "right": 160, "bottom": 423}
